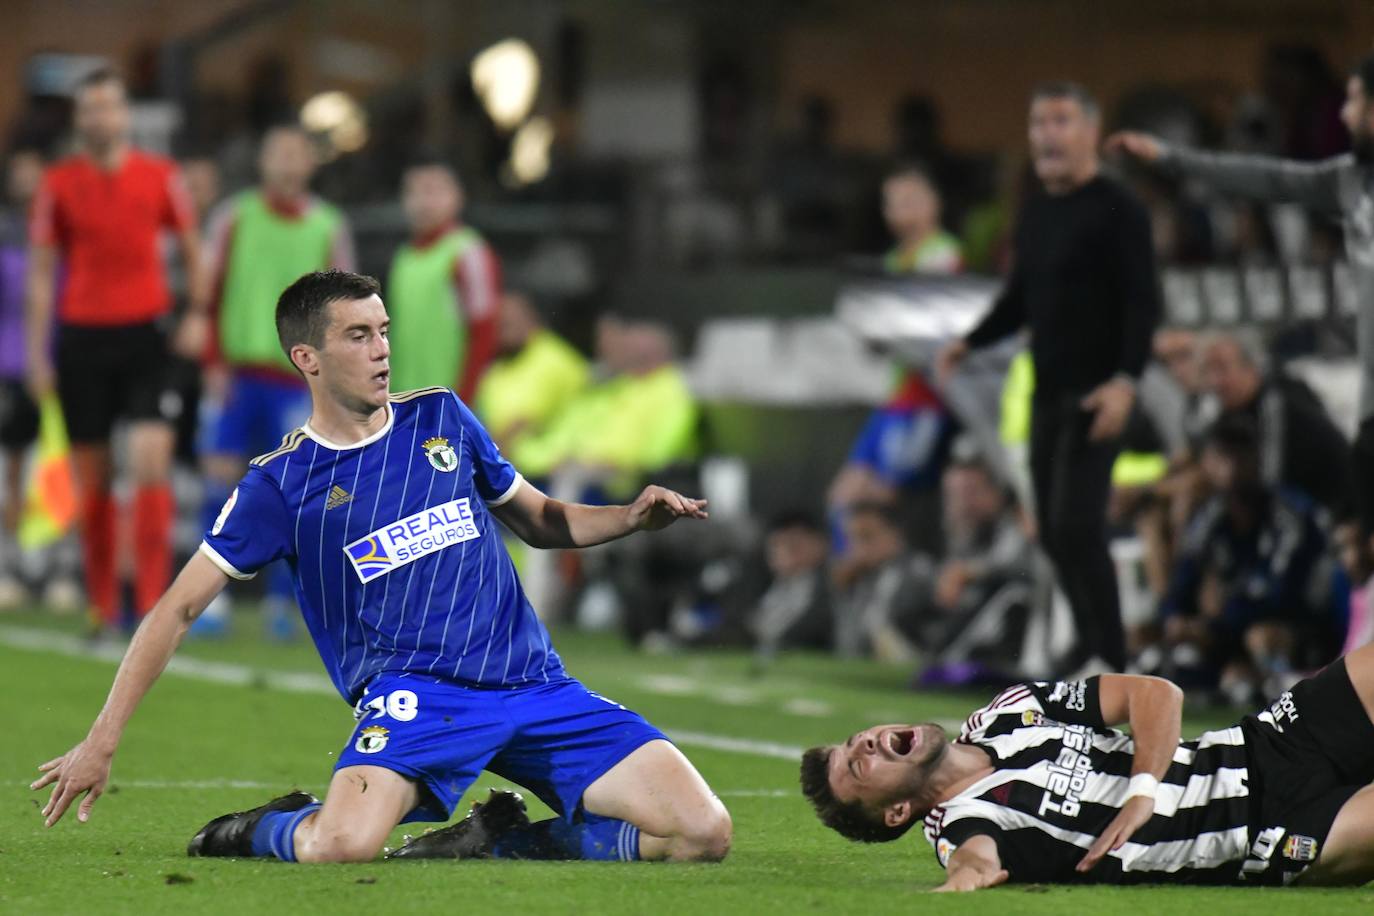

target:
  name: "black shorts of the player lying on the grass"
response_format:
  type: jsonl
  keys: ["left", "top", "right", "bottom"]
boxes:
{"left": 1241, "top": 658, "right": 1374, "bottom": 884}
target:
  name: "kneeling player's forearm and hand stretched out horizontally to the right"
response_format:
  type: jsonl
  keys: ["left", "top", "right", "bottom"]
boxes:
{"left": 492, "top": 481, "right": 706, "bottom": 549}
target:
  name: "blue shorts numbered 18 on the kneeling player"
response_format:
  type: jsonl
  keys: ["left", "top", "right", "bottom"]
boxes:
{"left": 335, "top": 674, "right": 668, "bottom": 821}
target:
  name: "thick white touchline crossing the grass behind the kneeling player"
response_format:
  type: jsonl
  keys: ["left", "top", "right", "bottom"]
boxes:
{"left": 0, "top": 626, "right": 802, "bottom": 761}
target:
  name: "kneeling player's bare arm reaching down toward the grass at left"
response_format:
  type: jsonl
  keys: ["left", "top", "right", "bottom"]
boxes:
{"left": 29, "top": 552, "right": 228, "bottom": 827}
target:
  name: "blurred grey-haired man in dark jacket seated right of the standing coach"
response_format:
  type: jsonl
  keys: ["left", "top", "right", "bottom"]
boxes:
{"left": 1202, "top": 334, "right": 1351, "bottom": 514}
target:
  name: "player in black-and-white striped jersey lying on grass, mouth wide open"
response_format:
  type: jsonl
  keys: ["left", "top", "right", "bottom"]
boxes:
{"left": 801, "top": 647, "right": 1374, "bottom": 890}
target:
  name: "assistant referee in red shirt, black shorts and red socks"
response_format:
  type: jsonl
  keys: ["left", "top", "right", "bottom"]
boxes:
{"left": 27, "top": 70, "right": 207, "bottom": 629}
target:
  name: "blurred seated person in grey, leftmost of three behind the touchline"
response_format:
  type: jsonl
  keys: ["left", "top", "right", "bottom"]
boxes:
{"left": 747, "top": 512, "right": 835, "bottom": 656}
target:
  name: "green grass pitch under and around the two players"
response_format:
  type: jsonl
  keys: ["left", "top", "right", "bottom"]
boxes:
{"left": 0, "top": 612, "right": 1374, "bottom": 916}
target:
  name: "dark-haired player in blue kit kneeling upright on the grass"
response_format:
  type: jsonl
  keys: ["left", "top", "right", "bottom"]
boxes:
{"left": 33, "top": 271, "right": 731, "bottom": 862}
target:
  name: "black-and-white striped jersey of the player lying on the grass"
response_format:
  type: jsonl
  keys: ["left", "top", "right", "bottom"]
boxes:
{"left": 925, "top": 677, "right": 1250, "bottom": 883}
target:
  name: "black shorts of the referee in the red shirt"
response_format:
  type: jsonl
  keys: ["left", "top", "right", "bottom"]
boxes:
{"left": 56, "top": 323, "right": 183, "bottom": 442}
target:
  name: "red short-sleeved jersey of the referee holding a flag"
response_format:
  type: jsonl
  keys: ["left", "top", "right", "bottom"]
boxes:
{"left": 29, "top": 150, "right": 195, "bottom": 325}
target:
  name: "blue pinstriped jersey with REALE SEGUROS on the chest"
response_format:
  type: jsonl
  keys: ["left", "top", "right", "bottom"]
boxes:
{"left": 201, "top": 389, "right": 565, "bottom": 703}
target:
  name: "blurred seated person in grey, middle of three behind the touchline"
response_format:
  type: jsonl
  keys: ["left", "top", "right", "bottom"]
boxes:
{"left": 834, "top": 503, "right": 929, "bottom": 662}
